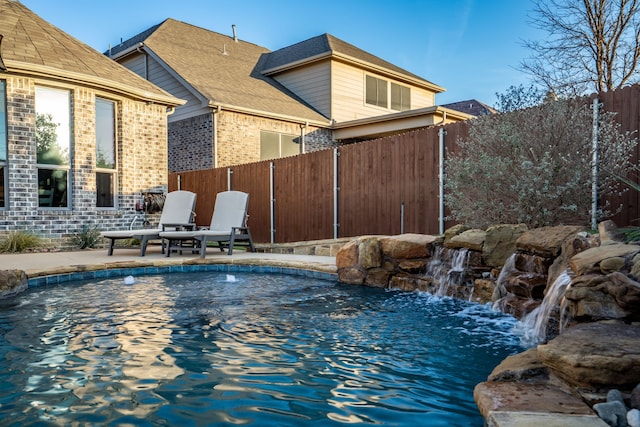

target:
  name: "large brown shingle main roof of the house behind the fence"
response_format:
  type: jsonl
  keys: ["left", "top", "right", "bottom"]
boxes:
{"left": 111, "top": 18, "right": 329, "bottom": 125}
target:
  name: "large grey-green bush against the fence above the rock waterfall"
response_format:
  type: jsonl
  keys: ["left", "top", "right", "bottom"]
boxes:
{"left": 445, "top": 100, "right": 637, "bottom": 228}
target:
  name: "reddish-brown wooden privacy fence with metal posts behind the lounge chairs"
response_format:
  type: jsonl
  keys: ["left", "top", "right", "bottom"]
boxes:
{"left": 168, "top": 86, "right": 640, "bottom": 243}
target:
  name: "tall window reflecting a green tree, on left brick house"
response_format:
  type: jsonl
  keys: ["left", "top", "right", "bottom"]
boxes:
{"left": 36, "top": 87, "right": 71, "bottom": 208}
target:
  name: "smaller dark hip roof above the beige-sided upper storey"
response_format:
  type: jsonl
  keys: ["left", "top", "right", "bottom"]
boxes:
{"left": 263, "top": 33, "right": 445, "bottom": 92}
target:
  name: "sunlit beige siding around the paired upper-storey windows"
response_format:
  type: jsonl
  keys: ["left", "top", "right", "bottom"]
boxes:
{"left": 331, "top": 62, "right": 434, "bottom": 122}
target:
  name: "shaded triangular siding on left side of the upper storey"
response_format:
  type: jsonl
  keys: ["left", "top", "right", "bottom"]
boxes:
{"left": 275, "top": 61, "right": 331, "bottom": 117}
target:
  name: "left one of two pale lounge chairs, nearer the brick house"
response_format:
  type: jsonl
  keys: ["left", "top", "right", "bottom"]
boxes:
{"left": 100, "top": 190, "right": 196, "bottom": 256}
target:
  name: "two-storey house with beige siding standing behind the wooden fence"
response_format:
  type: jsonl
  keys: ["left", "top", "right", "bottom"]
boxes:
{"left": 106, "top": 19, "right": 472, "bottom": 172}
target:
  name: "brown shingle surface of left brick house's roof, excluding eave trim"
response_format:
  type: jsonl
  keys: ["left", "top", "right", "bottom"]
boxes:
{"left": 0, "top": 0, "right": 178, "bottom": 103}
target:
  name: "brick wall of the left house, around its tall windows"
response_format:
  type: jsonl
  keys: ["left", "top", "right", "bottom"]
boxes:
{"left": 0, "top": 74, "right": 167, "bottom": 240}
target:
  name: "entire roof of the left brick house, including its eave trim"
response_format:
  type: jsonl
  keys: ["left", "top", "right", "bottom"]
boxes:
{"left": 0, "top": 0, "right": 183, "bottom": 106}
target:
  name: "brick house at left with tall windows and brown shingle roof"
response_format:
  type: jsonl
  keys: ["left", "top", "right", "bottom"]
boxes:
{"left": 0, "top": 0, "right": 184, "bottom": 239}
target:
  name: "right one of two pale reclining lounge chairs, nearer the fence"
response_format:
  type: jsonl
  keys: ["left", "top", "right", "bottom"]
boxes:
{"left": 160, "top": 191, "right": 255, "bottom": 258}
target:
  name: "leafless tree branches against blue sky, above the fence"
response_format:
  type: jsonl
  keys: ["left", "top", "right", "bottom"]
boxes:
{"left": 520, "top": 0, "right": 640, "bottom": 97}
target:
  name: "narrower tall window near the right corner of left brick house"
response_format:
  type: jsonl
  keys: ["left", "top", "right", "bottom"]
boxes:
{"left": 96, "top": 98, "right": 116, "bottom": 208}
